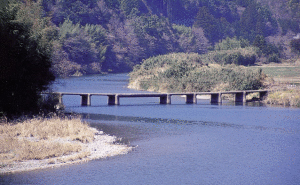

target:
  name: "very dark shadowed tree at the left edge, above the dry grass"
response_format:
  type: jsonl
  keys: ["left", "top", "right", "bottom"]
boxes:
{"left": 0, "top": 3, "right": 54, "bottom": 117}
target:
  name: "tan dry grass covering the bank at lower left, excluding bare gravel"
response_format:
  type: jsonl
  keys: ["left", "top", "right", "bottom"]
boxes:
{"left": 0, "top": 117, "right": 96, "bottom": 166}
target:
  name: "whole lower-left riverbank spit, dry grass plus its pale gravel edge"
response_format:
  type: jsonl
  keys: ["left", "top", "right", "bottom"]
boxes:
{"left": 0, "top": 117, "right": 132, "bottom": 174}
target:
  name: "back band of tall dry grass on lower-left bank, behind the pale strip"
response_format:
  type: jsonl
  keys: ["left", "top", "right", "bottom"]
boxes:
{"left": 0, "top": 117, "right": 96, "bottom": 143}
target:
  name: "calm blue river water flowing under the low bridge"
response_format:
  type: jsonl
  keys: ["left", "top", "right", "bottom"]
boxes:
{"left": 0, "top": 74, "right": 300, "bottom": 184}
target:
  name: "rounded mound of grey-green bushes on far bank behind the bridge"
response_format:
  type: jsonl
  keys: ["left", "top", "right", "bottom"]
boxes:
{"left": 129, "top": 53, "right": 266, "bottom": 92}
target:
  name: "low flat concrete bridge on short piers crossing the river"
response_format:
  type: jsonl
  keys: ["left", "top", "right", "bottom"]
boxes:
{"left": 47, "top": 90, "right": 269, "bottom": 106}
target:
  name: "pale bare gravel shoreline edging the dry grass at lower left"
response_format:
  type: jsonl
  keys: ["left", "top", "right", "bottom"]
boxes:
{"left": 0, "top": 131, "right": 133, "bottom": 174}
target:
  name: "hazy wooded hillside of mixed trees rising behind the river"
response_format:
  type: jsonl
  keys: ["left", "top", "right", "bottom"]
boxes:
{"left": 1, "top": 0, "right": 300, "bottom": 77}
